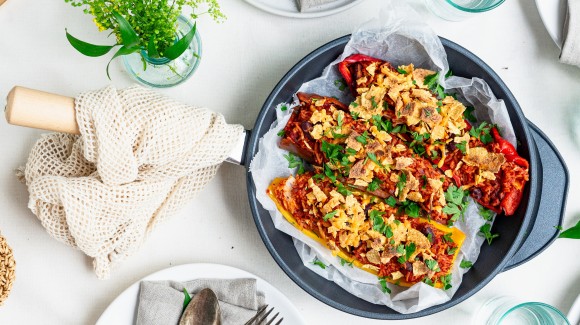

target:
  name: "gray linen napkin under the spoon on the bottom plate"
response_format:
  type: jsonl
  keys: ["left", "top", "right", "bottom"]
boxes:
{"left": 136, "top": 279, "right": 265, "bottom": 325}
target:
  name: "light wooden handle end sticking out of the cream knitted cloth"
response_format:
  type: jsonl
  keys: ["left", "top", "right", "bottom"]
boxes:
{"left": 5, "top": 86, "right": 80, "bottom": 134}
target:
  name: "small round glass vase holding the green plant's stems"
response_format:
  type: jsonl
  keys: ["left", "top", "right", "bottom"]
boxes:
{"left": 123, "top": 15, "right": 201, "bottom": 88}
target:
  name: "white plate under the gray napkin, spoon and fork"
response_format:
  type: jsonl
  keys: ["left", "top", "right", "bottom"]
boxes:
{"left": 97, "top": 264, "right": 306, "bottom": 325}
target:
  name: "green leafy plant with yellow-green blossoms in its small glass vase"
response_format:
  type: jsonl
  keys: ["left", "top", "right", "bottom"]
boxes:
{"left": 65, "top": 0, "right": 226, "bottom": 87}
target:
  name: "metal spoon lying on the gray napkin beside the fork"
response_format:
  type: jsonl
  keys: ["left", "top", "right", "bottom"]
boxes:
{"left": 179, "top": 288, "right": 222, "bottom": 325}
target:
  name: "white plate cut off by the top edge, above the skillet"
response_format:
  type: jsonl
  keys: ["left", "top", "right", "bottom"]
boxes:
{"left": 246, "top": 0, "right": 363, "bottom": 18}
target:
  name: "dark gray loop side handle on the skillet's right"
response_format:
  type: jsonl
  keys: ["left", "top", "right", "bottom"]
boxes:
{"left": 503, "top": 121, "right": 569, "bottom": 271}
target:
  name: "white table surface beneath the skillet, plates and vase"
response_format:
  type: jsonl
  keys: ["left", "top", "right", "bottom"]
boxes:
{"left": 0, "top": 0, "right": 580, "bottom": 324}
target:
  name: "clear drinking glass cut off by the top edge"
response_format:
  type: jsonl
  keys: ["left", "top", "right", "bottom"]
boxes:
{"left": 425, "top": 0, "right": 505, "bottom": 21}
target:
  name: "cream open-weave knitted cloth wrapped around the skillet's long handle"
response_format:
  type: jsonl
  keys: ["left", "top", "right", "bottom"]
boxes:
{"left": 19, "top": 87, "right": 244, "bottom": 279}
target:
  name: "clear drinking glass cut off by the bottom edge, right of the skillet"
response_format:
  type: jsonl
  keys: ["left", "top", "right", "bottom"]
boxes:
{"left": 472, "top": 296, "right": 570, "bottom": 325}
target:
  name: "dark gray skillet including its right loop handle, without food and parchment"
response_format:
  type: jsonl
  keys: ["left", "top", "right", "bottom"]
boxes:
{"left": 244, "top": 35, "right": 568, "bottom": 319}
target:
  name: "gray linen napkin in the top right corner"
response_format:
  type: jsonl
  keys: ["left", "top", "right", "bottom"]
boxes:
{"left": 560, "top": 0, "right": 580, "bottom": 66}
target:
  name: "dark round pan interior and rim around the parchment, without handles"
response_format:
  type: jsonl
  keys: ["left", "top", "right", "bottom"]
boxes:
{"left": 246, "top": 35, "right": 541, "bottom": 319}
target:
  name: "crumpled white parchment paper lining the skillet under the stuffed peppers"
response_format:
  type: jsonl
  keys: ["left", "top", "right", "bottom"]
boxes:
{"left": 250, "top": 0, "right": 516, "bottom": 313}
